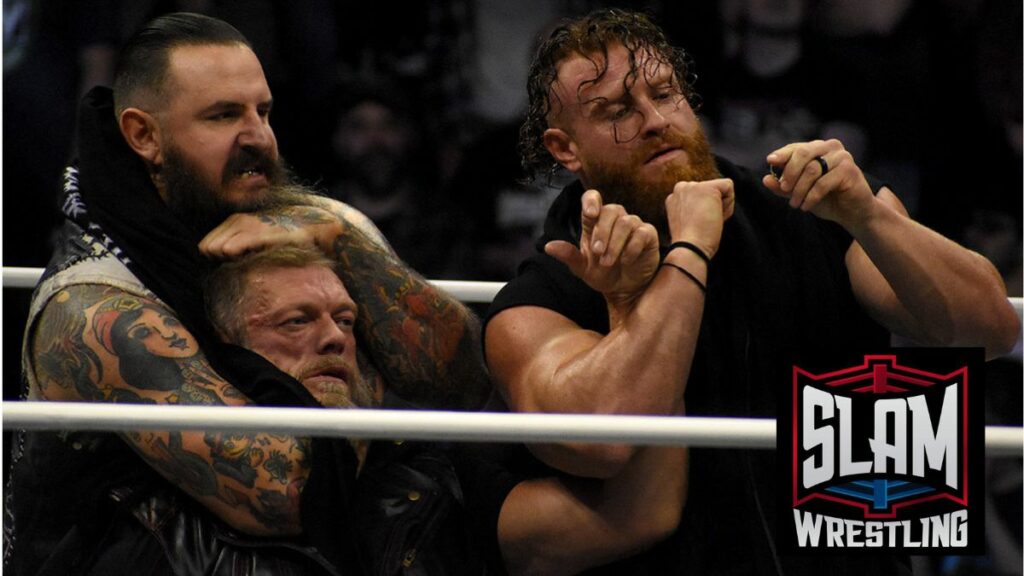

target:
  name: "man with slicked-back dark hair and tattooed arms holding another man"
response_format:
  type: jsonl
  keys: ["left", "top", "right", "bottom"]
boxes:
{"left": 4, "top": 13, "right": 489, "bottom": 575}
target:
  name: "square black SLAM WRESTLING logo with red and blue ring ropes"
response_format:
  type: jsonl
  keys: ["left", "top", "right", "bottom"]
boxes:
{"left": 778, "top": 348, "right": 985, "bottom": 554}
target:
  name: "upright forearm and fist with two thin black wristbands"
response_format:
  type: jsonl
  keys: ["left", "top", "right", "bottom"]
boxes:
{"left": 542, "top": 178, "right": 734, "bottom": 414}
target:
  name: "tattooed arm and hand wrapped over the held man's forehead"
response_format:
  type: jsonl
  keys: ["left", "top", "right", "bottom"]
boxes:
{"left": 200, "top": 196, "right": 490, "bottom": 409}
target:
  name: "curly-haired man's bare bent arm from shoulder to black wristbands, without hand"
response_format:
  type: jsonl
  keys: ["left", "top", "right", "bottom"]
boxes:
{"left": 487, "top": 252, "right": 705, "bottom": 478}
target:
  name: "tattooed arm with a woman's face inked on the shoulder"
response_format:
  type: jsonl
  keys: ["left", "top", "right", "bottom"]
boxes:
{"left": 30, "top": 285, "right": 309, "bottom": 535}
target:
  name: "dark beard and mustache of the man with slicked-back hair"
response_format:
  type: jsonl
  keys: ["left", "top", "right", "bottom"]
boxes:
{"left": 160, "top": 145, "right": 313, "bottom": 241}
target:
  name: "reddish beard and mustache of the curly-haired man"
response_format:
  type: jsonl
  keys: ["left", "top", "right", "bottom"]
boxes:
{"left": 588, "top": 125, "right": 722, "bottom": 235}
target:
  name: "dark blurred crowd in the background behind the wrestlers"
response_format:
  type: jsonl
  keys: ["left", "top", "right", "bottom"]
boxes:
{"left": 2, "top": 0, "right": 1024, "bottom": 574}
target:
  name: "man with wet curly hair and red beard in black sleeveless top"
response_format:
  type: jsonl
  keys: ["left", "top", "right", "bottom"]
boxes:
{"left": 484, "top": 9, "right": 1020, "bottom": 575}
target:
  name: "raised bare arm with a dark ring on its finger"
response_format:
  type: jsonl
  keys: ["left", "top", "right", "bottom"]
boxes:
{"left": 762, "top": 139, "right": 1020, "bottom": 358}
